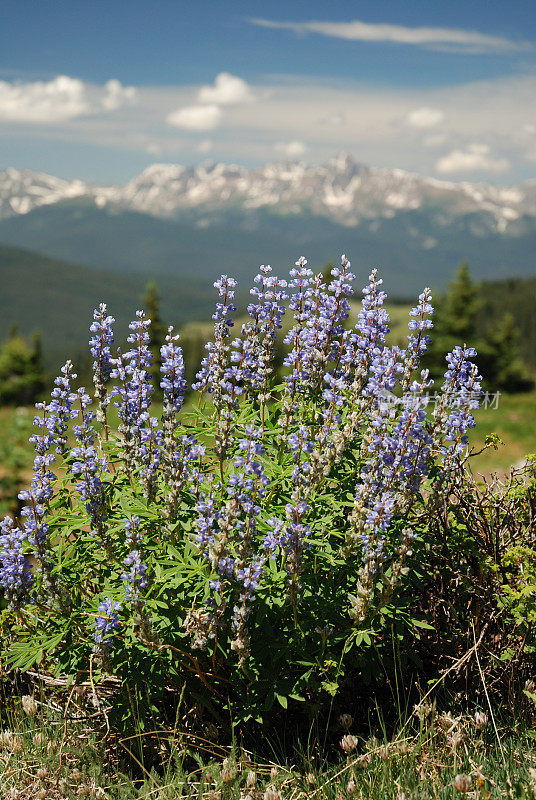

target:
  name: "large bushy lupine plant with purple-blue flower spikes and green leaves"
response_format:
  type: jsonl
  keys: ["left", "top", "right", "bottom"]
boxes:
{"left": 0, "top": 256, "right": 502, "bottom": 732}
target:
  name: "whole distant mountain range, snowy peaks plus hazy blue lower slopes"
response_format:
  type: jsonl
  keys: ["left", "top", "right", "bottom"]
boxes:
{"left": 0, "top": 155, "right": 536, "bottom": 297}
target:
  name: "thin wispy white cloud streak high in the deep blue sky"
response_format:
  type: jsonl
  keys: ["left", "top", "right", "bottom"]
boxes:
{"left": 249, "top": 18, "right": 532, "bottom": 54}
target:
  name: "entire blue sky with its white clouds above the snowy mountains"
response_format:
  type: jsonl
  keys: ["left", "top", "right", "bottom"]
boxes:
{"left": 0, "top": 0, "right": 536, "bottom": 183}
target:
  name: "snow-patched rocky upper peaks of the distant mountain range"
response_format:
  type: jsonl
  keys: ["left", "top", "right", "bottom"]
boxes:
{"left": 0, "top": 155, "right": 536, "bottom": 234}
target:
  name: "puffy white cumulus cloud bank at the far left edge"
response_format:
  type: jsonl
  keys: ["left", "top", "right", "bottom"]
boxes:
{"left": 0, "top": 75, "right": 137, "bottom": 124}
